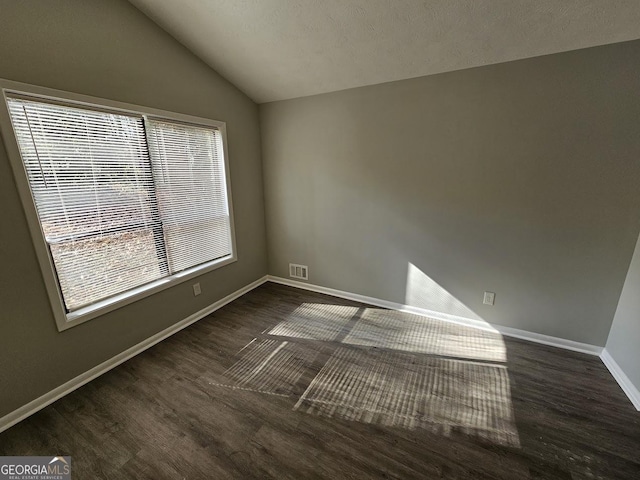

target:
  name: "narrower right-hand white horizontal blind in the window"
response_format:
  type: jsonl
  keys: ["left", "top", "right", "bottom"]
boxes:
{"left": 147, "top": 120, "right": 231, "bottom": 272}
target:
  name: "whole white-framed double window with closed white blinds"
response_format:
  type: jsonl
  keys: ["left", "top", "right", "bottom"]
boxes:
{"left": 3, "top": 82, "right": 235, "bottom": 329}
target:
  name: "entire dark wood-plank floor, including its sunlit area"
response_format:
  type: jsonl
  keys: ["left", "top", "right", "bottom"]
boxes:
{"left": 0, "top": 283, "right": 640, "bottom": 480}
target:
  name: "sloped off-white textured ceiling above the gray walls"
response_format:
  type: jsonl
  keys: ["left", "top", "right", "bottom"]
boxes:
{"left": 130, "top": 0, "right": 640, "bottom": 103}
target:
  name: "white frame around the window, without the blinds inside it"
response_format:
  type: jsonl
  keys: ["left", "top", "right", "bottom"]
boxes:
{"left": 0, "top": 78, "right": 238, "bottom": 332}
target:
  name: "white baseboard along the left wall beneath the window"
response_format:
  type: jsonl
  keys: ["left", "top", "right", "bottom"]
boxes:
{"left": 0, "top": 275, "right": 267, "bottom": 432}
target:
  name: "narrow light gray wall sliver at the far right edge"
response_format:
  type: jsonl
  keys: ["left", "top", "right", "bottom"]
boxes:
{"left": 606, "top": 232, "right": 640, "bottom": 391}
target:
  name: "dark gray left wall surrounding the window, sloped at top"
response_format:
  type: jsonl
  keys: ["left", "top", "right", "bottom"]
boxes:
{"left": 0, "top": 0, "right": 267, "bottom": 417}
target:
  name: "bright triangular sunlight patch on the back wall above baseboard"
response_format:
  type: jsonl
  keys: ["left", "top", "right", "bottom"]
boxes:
{"left": 405, "top": 263, "right": 482, "bottom": 320}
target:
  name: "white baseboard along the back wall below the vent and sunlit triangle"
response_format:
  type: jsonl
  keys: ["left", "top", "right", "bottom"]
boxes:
{"left": 267, "top": 275, "right": 602, "bottom": 356}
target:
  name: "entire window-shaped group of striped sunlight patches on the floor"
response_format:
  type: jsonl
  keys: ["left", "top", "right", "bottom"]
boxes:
{"left": 210, "top": 303, "right": 519, "bottom": 447}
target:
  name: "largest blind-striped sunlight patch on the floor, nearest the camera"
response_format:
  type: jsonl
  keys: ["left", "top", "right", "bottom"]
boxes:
{"left": 294, "top": 348, "right": 519, "bottom": 446}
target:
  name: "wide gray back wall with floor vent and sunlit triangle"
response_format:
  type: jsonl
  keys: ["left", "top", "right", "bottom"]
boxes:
{"left": 260, "top": 42, "right": 640, "bottom": 346}
